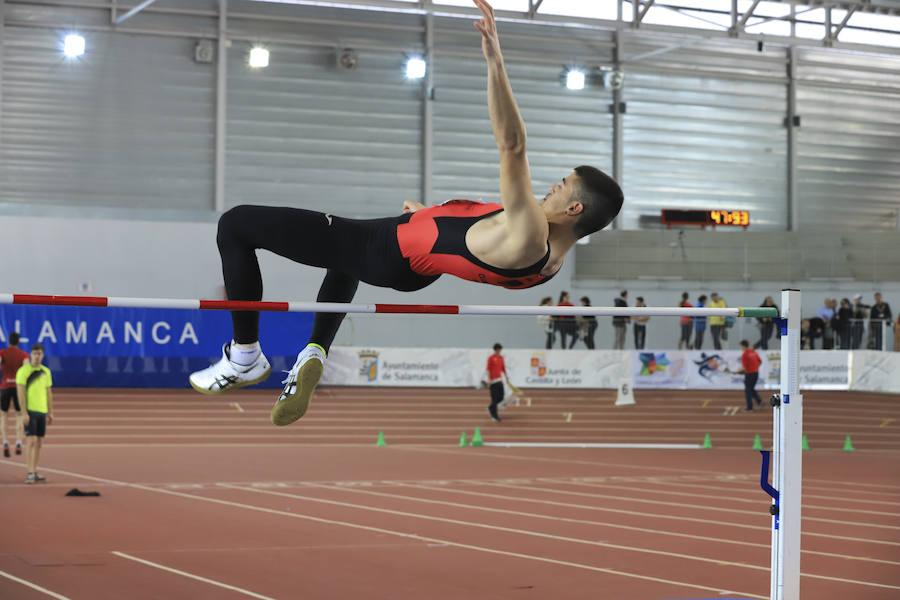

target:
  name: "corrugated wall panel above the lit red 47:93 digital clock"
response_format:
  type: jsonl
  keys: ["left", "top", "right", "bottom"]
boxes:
{"left": 623, "top": 36, "right": 787, "bottom": 230}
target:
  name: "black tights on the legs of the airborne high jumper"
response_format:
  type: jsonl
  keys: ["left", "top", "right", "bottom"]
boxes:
{"left": 216, "top": 206, "right": 439, "bottom": 352}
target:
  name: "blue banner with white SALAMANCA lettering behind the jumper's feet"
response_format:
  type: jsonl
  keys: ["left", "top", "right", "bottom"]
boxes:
{"left": 0, "top": 305, "right": 313, "bottom": 388}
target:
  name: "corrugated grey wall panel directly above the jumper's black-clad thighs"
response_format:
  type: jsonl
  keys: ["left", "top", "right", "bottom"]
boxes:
{"left": 226, "top": 46, "right": 423, "bottom": 217}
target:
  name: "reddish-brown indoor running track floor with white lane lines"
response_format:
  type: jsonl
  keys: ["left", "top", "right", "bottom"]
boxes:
{"left": 0, "top": 388, "right": 900, "bottom": 600}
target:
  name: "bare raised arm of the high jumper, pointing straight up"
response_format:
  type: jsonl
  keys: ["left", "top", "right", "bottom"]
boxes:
{"left": 473, "top": 0, "right": 548, "bottom": 240}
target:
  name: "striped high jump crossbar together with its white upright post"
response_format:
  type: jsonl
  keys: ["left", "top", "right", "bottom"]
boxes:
{"left": 0, "top": 290, "right": 803, "bottom": 600}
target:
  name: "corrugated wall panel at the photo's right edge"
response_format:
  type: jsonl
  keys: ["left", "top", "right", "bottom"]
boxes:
{"left": 797, "top": 49, "right": 900, "bottom": 231}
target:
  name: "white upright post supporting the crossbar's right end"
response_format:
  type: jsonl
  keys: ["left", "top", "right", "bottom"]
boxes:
{"left": 771, "top": 290, "right": 803, "bottom": 600}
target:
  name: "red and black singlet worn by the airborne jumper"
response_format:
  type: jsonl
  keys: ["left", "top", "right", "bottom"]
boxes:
{"left": 397, "top": 200, "right": 553, "bottom": 289}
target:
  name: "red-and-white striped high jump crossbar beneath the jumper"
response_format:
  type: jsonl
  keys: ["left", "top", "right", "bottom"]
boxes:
{"left": 0, "top": 294, "right": 778, "bottom": 317}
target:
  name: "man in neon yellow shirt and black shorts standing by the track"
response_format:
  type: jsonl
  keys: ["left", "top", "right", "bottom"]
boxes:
{"left": 16, "top": 344, "right": 53, "bottom": 483}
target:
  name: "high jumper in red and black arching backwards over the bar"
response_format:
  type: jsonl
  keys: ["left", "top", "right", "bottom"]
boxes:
{"left": 190, "top": 0, "right": 623, "bottom": 425}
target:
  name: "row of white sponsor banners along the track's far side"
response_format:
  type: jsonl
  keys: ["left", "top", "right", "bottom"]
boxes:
{"left": 321, "top": 346, "right": 856, "bottom": 391}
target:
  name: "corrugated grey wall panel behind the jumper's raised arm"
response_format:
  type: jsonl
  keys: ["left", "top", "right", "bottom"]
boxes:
{"left": 434, "top": 19, "right": 612, "bottom": 202}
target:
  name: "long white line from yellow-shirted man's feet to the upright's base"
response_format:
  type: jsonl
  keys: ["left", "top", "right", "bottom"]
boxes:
{"left": 7, "top": 468, "right": 769, "bottom": 600}
